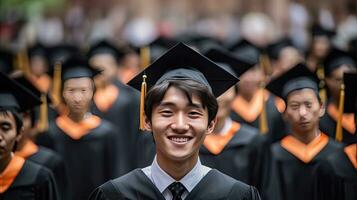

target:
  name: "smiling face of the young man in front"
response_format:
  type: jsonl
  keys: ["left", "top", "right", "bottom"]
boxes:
{"left": 146, "top": 87, "right": 215, "bottom": 161}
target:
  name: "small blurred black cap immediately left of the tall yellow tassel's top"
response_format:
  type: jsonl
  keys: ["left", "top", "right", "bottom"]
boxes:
{"left": 228, "top": 39, "right": 262, "bottom": 64}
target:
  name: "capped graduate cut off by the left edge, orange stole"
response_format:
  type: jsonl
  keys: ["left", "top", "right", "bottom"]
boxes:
{"left": 0, "top": 72, "right": 58, "bottom": 200}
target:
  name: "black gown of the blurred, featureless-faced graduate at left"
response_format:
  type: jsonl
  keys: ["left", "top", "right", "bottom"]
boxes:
{"left": 38, "top": 120, "right": 119, "bottom": 200}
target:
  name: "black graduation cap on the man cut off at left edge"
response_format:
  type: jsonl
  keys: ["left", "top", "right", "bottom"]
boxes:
{"left": 0, "top": 72, "right": 41, "bottom": 111}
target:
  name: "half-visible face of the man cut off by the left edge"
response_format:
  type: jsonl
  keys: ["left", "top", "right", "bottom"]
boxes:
{"left": 0, "top": 112, "right": 20, "bottom": 160}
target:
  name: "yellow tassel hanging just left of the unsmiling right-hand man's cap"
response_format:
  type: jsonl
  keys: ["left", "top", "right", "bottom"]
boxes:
{"left": 259, "top": 54, "right": 272, "bottom": 134}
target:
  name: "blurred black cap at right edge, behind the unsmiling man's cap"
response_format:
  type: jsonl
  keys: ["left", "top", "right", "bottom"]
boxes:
{"left": 324, "top": 48, "right": 356, "bottom": 76}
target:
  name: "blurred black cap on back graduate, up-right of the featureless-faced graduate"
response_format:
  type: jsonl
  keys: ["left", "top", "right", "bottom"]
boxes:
{"left": 87, "top": 40, "right": 126, "bottom": 62}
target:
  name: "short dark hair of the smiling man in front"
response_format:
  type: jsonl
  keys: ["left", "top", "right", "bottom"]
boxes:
{"left": 145, "top": 80, "right": 218, "bottom": 123}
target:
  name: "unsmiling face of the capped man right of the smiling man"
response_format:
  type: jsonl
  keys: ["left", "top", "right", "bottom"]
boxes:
{"left": 284, "top": 88, "right": 324, "bottom": 133}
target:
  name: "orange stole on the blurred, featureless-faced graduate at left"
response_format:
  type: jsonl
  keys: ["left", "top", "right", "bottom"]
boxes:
{"left": 56, "top": 115, "right": 101, "bottom": 140}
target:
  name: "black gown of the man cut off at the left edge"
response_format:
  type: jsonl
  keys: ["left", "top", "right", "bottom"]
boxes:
{"left": 0, "top": 160, "right": 59, "bottom": 200}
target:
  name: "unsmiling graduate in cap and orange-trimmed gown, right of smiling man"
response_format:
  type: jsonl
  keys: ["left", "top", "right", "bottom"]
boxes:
{"left": 264, "top": 64, "right": 341, "bottom": 200}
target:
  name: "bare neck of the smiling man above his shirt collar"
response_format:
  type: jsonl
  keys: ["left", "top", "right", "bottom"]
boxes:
{"left": 157, "top": 154, "right": 198, "bottom": 181}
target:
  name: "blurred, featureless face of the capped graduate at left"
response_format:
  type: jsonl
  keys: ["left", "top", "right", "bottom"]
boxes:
{"left": 62, "top": 77, "right": 94, "bottom": 113}
